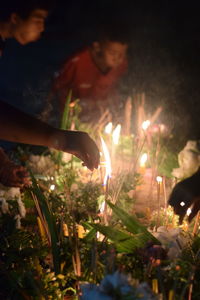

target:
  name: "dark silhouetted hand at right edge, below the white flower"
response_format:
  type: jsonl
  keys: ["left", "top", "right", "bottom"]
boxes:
{"left": 169, "top": 170, "right": 200, "bottom": 223}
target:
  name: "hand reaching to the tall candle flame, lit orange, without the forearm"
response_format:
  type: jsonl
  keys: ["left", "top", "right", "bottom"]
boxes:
{"left": 54, "top": 130, "right": 100, "bottom": 171}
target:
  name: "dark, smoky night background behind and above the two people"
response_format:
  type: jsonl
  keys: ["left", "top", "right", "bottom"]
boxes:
{"left": 0, "top": 0, "right": 200, "bottom": 144}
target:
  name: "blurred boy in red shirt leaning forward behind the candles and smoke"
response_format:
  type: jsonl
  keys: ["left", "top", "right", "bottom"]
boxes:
{"left": 53, "top": 33, "right": 128, "bottom": 121}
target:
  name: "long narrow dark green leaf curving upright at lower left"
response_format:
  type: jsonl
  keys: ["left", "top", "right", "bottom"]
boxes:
{"left": 30, "top": 172, "right": 60, "bottom": 274}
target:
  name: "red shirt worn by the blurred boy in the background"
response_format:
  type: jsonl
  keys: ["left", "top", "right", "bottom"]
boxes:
{"left": 54, "top": 48, "right": 127, "bottom": 109}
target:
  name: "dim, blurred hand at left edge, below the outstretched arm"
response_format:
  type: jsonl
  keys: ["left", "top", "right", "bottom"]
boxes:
{"left": 0, "top": 161, "right": 30, "bottom": 188}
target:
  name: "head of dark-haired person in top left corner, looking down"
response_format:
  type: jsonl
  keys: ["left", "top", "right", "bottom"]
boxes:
{"left": 0, "top": 0, "right": 52, "bottom": 45}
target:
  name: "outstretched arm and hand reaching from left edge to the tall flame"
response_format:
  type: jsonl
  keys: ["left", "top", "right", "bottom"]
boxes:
{"left": 0, "top": 101, "right": 99, "bottom": 170}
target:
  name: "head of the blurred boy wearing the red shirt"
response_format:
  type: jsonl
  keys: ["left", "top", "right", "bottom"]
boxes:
{"left": 93, "top": 25, "right": 128, "bottom": 69}
